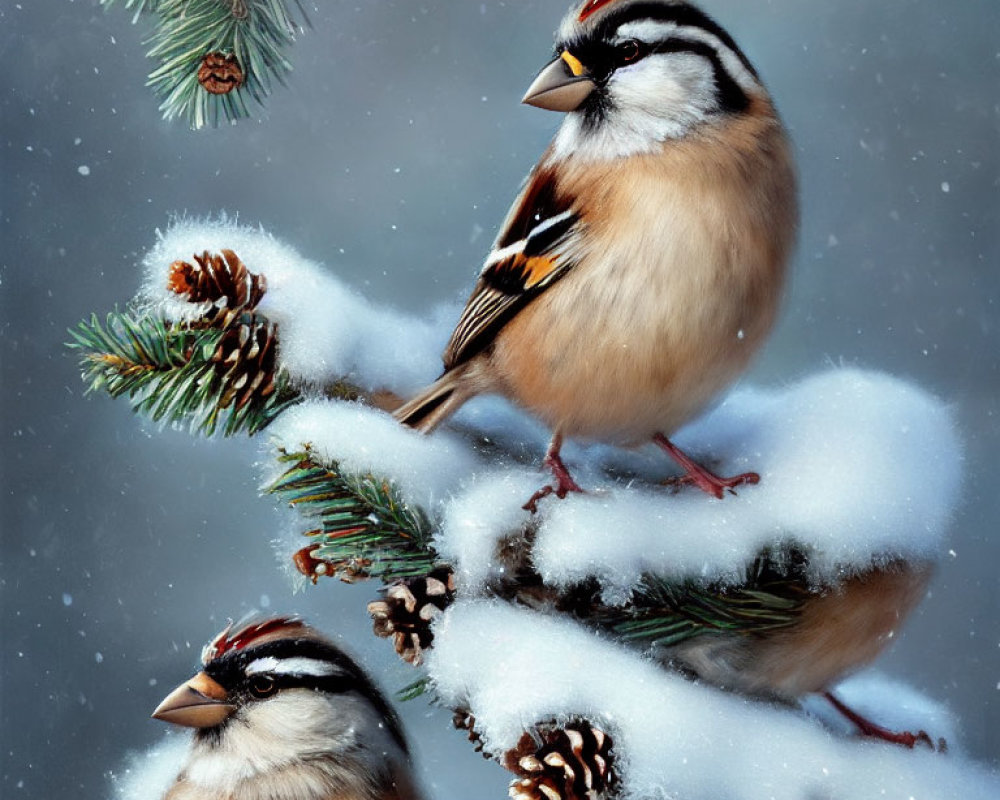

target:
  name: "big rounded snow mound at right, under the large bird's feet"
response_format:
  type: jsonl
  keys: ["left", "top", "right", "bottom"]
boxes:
{"left": 508, "top": 369, "right": 961, "bottom": 595}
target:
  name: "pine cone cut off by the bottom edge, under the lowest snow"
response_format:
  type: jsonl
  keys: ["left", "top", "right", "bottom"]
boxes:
{"left": 505, "top": 721, "right": 615, "bottom": 800}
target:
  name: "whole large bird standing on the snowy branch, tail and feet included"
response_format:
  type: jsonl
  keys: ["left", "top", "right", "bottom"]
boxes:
{"left": 396, "top": 0, "right": 797, "bottom": 506}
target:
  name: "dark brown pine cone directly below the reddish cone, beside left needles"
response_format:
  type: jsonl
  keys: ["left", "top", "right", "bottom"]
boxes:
{"left": 212, "top": 319, "right": 278, "bottom": 410}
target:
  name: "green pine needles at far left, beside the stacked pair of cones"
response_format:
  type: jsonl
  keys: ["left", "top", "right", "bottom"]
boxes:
{"left": 68, "top": 311, "right": 300, "bottom": 436}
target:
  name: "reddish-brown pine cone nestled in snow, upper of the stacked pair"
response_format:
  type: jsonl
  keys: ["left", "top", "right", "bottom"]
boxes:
{"left": 167, "top": 250, "right": 267, "bottom": 327}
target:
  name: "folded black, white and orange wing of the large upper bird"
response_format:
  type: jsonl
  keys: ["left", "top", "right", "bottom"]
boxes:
{"left": 444, "top": 168, "right": 582, "bottom": 370}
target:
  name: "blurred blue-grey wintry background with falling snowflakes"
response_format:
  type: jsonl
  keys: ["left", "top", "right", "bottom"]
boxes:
{"left": 0, "top": 0, "right": 1000, "bottom": 800}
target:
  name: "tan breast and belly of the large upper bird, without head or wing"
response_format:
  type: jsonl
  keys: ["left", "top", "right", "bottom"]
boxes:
{"left": 480, "top": 106, "right": 796, "bottom": 445}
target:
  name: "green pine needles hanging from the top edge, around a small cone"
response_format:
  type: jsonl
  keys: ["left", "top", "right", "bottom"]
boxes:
{"left": 101, "top": 0, "right": 307, "bottom": 129}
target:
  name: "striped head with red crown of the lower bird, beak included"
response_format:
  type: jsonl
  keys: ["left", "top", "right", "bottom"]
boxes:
{"left": 153, "top": 617, "right": 408, "bottom": 785}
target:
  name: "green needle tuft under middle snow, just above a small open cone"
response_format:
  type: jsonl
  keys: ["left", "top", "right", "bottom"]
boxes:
{"left": 265, "top": 449, "right": 437, "bottom": 582}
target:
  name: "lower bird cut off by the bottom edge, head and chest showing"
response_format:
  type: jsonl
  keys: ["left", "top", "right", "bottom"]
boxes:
{"left": 153, "top": 618, "right": 420, "bottom": 800}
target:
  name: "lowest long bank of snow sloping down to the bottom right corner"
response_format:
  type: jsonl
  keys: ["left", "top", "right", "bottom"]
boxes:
{"left": 428, "top": 600, "right": 1000, "bottom": 800}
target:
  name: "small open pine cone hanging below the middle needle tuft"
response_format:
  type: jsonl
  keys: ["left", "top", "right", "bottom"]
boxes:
{"left": 368, "top": 567, "right": 455, "bottom": 667}
